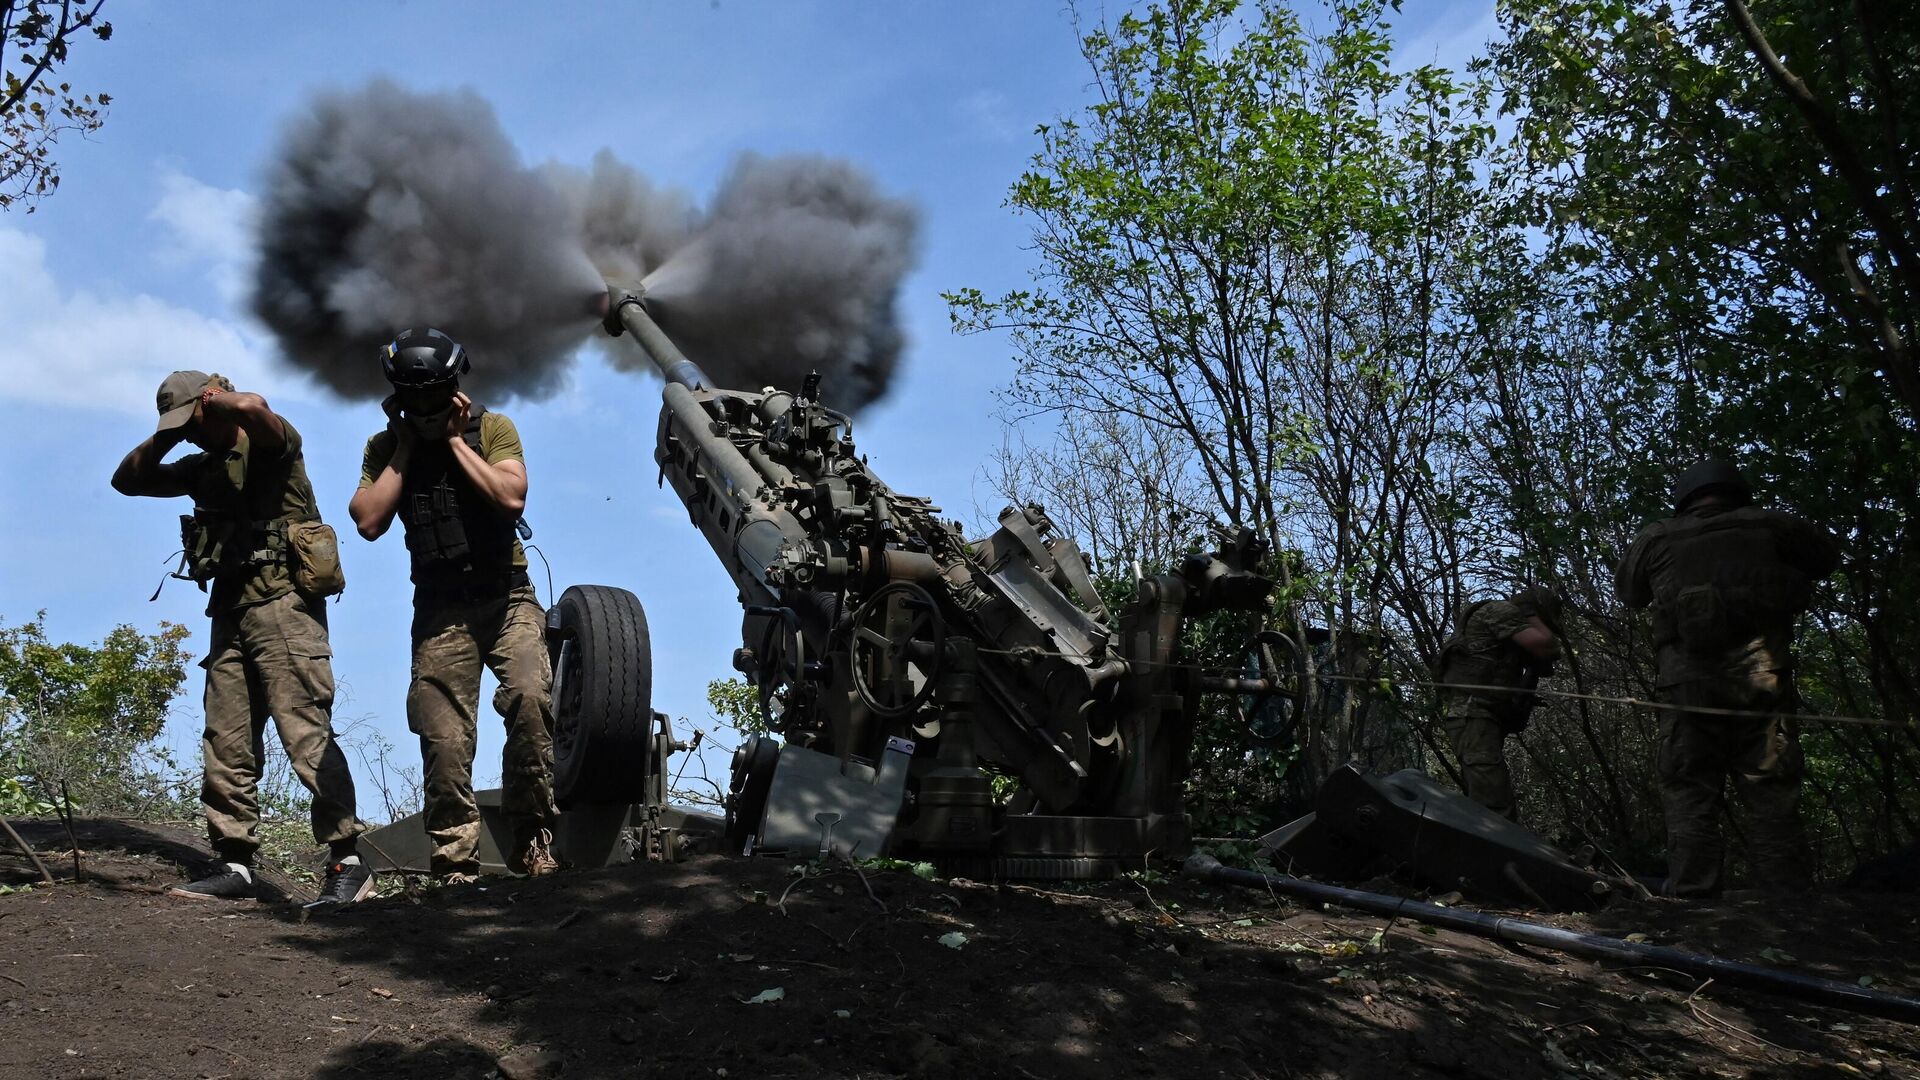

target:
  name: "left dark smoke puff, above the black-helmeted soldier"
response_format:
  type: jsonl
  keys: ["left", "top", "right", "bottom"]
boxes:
{"left": 253, "top": 81, "right": 603, "bottom": 398}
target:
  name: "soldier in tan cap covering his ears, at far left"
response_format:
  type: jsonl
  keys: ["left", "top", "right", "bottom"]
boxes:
{"left": 113, "top": 371, "right": 372, "bottom": 903}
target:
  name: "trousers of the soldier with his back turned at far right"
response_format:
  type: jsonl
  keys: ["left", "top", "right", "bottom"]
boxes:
{"left": 1657, "top": 673, "right": 1812, "bottom": 896}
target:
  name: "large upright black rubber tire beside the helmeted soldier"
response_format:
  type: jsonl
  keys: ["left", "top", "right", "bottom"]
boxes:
{"left": 551, "top": 584, "right": 653, "bottom": 807}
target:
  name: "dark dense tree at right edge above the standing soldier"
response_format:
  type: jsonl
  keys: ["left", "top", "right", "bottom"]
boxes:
{"left": 1492, "top": 0, "right": 1920, "bottom": 851}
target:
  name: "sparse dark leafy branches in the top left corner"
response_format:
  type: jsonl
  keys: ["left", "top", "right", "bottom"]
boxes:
{"left": 0, "top": 0, "right": 113, "bottom": 213}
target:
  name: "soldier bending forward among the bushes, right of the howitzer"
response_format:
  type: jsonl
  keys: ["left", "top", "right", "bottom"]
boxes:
{"left": 1434, "top": 588, "right": 1561, "bottom": 821}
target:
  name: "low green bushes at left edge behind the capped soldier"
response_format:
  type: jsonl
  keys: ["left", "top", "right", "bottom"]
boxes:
{"left": 0, "top": 613, "right": 192, "bottom": 813}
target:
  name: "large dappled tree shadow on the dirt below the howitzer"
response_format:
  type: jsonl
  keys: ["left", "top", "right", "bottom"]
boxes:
{"left": 286, "top": 859, "right": 1574, "bottom": 1078}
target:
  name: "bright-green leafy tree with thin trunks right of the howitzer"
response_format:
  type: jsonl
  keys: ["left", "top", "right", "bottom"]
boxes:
{"left": 948, "top": 0, "right": 1500, "bottom": 794}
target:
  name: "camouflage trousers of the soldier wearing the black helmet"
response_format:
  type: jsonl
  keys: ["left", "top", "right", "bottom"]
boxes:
{"left": 407, "top": 586, "right": 555, "bottom": 874}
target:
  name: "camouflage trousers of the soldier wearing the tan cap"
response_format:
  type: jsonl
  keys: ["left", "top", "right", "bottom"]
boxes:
{"left": 200, "top": 592, "right": 365, "bottom": 863}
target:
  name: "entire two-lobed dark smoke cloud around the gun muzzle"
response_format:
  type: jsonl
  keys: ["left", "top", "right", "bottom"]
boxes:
{"left": 253, "top": 81, "right": 918, "bottom": 409}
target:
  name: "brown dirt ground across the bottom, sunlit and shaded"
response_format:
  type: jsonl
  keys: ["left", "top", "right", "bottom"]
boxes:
{"left": 0, "top": 821, "right": 1920, "bottom": 1080}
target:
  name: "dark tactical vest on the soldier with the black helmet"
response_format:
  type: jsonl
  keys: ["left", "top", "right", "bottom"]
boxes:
{"left": 399, "top": 405, "right": 515, "bottom": 584}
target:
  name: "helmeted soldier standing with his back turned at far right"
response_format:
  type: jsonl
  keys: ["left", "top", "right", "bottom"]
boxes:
{"left": 1615, "top": 459, "right": 1839, "bottom": 896}
